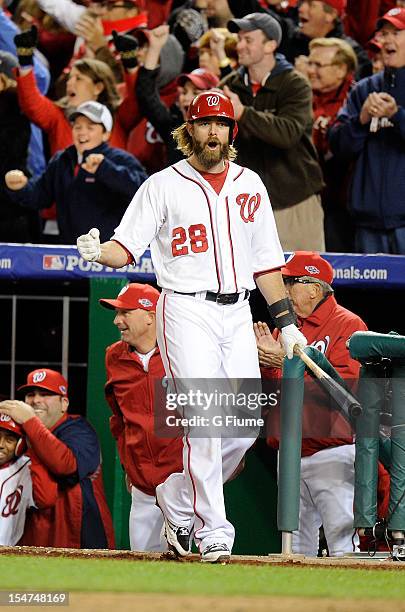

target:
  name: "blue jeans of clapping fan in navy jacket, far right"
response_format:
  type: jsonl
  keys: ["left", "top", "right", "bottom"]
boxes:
{"left": 355, "top": 227, "right": 405, "bottom": 255}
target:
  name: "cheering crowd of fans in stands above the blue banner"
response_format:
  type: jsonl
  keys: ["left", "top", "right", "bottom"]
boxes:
{"left": 0, "top": 0, "right": 405, "bottom": 254}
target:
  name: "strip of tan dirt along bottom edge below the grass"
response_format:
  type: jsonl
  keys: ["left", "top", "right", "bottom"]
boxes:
{"left": 68, "top": 593, "right": 405, "bottom": 612}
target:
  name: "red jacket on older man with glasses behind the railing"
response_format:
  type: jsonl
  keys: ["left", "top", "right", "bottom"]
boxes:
{"left": 262, "top": 296, "right": 367, "bottom": 457}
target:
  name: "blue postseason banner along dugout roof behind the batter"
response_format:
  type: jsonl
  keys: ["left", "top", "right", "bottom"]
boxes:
{"left": 0, "top": 243, "right": 405, "bottom": 289}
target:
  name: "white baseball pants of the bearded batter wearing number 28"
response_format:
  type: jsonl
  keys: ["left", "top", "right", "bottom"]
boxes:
{"left": 157, "top": 291, "right": 260, "bottom": 552}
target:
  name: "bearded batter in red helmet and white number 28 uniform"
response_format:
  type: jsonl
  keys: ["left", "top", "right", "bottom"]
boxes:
{"left": 77, "top": 90, "right": 306, "bottom": 563}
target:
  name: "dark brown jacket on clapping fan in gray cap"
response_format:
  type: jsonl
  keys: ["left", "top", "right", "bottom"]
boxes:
{"left": 221, "top": 55, "right": 323, "bottom": 208}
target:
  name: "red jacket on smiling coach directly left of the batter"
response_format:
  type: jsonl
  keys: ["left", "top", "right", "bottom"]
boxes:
{"left": 105, "top": 341, "right": 183, "bottom": 495}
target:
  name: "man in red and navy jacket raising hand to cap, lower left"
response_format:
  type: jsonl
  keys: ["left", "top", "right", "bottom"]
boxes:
{"left": 0, "top": 368, "right": 114, "bottom": 548}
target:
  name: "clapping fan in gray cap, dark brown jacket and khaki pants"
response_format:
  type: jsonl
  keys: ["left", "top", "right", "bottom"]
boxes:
{"left": 222, "top": 13, "right": 325, "bottom": 251}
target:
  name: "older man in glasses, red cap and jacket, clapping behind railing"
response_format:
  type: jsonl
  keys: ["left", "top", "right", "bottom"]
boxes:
{"left": 255, "top": 251, "right": 367, "bottom": 556}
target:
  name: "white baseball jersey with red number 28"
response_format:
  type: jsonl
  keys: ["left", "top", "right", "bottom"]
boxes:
{"left": 113, "top": 160, "right": 284, "bottom": 293}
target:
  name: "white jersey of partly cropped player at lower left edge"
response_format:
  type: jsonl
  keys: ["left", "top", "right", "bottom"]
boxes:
{"left": 0, "top": 455, "right": 35, "bottom": 546}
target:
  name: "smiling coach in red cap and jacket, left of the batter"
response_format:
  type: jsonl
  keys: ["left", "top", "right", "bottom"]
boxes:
{"left": 100, "top": 283, "right": 183, "bottom": 551}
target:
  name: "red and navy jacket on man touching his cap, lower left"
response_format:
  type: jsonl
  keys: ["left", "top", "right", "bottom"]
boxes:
{"left": 19, "top": 415, "right": 115, "bottom": 548}
